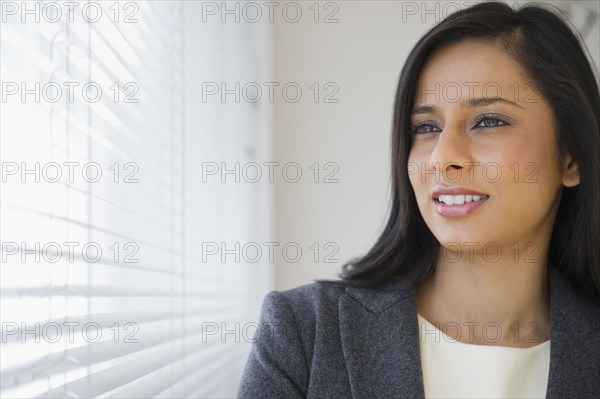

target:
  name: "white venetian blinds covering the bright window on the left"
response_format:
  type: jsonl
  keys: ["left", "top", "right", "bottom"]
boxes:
{"left": 0, "top": 1, "right": 271, "bottom": 398}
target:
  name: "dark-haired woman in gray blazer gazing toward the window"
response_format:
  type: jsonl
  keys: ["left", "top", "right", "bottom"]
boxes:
{"left": 238, "top": 3, "right": 600, "bottom": 398}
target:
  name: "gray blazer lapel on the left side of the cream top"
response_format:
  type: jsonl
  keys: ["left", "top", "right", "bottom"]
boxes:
{"left": 338, "top": 282, "right": 425, "bottom": 398}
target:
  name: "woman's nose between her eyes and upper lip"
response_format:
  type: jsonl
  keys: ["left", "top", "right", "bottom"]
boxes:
{"left": 429, "top": 125, "right": 473, "bottom": 182}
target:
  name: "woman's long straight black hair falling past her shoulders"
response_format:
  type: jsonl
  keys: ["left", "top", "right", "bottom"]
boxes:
{"left": 317, "top": 2, "right": 600, "bottom": 302}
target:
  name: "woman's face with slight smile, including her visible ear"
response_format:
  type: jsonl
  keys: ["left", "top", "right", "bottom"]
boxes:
{"left": 408, "top": 40, "right": 579, "bottom": 260}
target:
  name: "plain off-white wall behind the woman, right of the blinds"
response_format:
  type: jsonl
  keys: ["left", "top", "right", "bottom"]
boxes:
{"left": 274, "top": 1, "right": 600, "bottom": 290}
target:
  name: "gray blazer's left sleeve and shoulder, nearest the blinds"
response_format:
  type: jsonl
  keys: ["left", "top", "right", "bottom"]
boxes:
{"left": 238, "top": 282, "right": 344, "bottom": 399}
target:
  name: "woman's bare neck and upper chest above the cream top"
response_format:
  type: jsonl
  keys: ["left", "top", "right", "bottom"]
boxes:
{"left": 417, "top": 254, "right": 550, "bottom": 347}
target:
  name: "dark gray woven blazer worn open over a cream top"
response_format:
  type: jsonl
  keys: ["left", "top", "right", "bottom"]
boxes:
{"left": 238, "top": 267, "right": 600, "bottom": 399}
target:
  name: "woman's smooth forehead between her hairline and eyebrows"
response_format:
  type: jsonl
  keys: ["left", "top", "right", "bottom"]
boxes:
{"left": 415, "top": 39, "right": 533, "bottom": 103}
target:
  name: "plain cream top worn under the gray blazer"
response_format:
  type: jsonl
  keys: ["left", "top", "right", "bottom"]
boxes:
{"left": 417, "top": 314, "right": 550, "bottom": 398}
